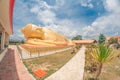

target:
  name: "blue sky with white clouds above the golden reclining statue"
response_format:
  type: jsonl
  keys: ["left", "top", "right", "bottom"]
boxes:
{"left": 10, "top": 0, "right": 120, "bottom": 39}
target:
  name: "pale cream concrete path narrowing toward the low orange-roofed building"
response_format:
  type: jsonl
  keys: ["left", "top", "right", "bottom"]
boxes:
{"left": 45, "top": 47, "right": 85, "bottom": 80}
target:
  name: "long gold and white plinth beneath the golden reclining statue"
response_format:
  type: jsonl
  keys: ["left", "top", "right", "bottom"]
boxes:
{"left": 17, "top": 45, "right": 72, "bottom": 59}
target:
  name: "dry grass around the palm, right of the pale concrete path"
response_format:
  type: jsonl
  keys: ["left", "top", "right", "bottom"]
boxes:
{"left": 84, "top": 47, "right": 120, "bottom": 80}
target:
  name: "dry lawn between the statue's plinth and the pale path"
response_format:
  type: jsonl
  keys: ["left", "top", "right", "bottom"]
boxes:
{"left": 23, "top": 49, "right": 75, "bottom": 80}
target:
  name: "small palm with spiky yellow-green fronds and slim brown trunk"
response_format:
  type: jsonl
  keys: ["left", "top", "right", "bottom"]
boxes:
{"left": 90, "top": 45, "right": 115, "bottom": 79}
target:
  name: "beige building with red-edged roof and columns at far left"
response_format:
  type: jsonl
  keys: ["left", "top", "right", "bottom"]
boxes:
{"left": 0, "top": 0, "right": 14, "bottom": 51}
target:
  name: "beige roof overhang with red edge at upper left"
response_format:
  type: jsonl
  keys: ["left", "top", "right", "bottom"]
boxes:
{"left": 0, "top": 0, "right": 14, "bottom": 34}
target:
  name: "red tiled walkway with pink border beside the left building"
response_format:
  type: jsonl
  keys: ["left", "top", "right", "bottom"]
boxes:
{"left": 0, "top": 46, "right": 34, "bottom": 80}
